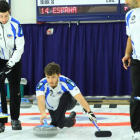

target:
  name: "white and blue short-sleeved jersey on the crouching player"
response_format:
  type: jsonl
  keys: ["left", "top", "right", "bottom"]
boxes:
{"left": 36, "top": 75, "right": 80, "bottom": 110}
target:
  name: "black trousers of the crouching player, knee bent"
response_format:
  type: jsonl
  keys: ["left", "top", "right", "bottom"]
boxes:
{"left": 49, "top": 92, "right": 77, "bottom": 128}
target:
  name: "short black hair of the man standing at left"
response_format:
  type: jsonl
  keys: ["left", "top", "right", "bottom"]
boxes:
{"left": 0, "top": 0, "right": 10, "bottom": 13}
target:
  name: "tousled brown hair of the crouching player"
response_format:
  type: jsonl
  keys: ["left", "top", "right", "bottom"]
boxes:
{"left": 44, "top": 62, "right": 60, "bottom": 76}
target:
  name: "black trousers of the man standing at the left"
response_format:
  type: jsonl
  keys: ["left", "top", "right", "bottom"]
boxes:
{"left": 0, "top": 59, "right": 21, "bottom": 123}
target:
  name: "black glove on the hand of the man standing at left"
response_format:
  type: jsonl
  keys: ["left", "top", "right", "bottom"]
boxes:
{"left": 0, "top": 65, "right": 12, "bottom": 80}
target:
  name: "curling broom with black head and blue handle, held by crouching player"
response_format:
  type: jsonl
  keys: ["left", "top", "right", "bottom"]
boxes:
{"left": 92, "top": 121, "right": 112, "bottom": 137}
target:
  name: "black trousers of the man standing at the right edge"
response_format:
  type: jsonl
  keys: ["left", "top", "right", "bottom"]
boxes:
{"left": 130, "top": 59, "right": 140, "bottom": 132}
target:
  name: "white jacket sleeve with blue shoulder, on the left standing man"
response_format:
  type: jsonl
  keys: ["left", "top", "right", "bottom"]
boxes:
{"left": 7, "top": 24, "right": 25, "bottom": 67}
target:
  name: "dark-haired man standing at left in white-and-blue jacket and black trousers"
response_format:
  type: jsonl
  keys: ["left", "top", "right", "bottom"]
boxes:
{"left": 0, "top": 1, "right": 25, "bottom": 132}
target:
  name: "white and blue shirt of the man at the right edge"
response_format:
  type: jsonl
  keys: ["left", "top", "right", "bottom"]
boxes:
{"left": 126, "top": 8, "right": 140, "bottom": 60}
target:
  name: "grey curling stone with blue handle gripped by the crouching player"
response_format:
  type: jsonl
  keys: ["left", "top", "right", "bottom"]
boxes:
{"left": 33, "top": 119, "right": 58, "bottom": 137}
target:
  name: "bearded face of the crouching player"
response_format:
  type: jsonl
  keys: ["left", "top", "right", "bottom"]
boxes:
{"left": 46, "top": 74, "right": 60, "bottom": 88}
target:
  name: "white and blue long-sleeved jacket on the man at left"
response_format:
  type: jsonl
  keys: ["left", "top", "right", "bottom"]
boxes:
{"left": 0, "top": 16, "right": 25, "bottom": 66}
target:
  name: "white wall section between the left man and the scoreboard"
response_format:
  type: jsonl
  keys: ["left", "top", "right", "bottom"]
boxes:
{"left": 11, "top": 0, "right": 36, "bottom": 24}
